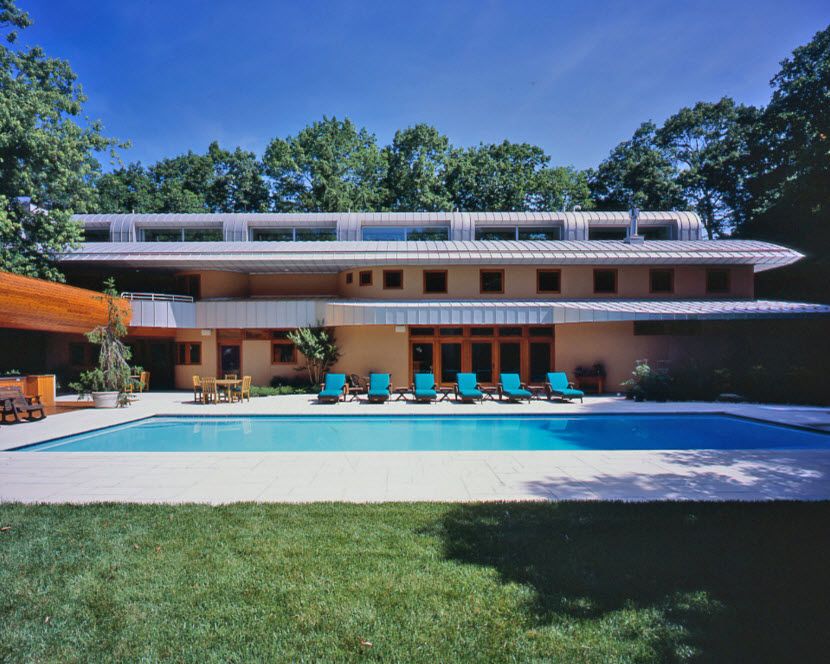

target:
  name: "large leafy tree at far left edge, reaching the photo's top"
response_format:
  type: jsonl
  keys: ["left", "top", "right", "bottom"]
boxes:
{"left": 0, "top": 0, "right": 118, "bottom": 280}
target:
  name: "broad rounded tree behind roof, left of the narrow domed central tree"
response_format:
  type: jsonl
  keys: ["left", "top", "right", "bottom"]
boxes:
{"left": 263, "top": 116, "right": 384, "bottom": 212}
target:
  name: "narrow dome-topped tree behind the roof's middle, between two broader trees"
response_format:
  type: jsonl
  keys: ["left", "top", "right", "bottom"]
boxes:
{"left": 383, "top": 124, "right": 452, "bottom": 212}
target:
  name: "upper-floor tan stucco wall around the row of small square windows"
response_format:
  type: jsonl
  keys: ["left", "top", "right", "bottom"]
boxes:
{"left": 339, "top": 265, "right": 753, "bottom": 300}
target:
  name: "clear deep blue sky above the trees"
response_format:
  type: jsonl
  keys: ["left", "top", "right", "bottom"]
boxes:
{"left": 19, "top": 0, "right": 830, "bottom": 168}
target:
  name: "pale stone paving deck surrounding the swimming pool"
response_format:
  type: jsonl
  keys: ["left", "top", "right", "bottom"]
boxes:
{"left": 0, "top": 392, "right": 830, "bottom": 503}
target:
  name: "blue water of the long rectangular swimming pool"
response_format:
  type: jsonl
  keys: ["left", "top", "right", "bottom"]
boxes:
{"left": 14, "top": 415, "right": 830, "bottom": 452}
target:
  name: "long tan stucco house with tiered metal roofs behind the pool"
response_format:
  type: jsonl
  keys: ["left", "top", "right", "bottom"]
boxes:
{"left": 13, "top": 212, "right": 830, "bottom": 391}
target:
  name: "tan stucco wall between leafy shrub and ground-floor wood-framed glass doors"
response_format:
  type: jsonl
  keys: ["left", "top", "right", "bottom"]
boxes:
{"left": 333, "top": 325, "right": 409, "bottom": 387}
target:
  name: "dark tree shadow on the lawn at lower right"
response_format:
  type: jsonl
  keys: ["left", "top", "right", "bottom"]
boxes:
{"left": 432, "top": 503, "right": 830, "bottom": 662}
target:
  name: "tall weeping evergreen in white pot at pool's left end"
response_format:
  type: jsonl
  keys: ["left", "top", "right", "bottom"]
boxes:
{"left": 71, "top": 278, "right": 132, "bottom": 408}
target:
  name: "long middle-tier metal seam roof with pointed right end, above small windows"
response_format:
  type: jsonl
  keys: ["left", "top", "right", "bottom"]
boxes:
{"left": 60, "top": 240, "right": 803, "bottom": 273}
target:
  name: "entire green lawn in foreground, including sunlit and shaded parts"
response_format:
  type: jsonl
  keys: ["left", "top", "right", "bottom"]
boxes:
{"left": 0, "top": 503, "right": 830, "bottom": 663}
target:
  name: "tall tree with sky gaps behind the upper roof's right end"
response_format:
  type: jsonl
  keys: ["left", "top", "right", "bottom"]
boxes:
{"left": 655, "top": 97, "right": 757, "bottom": 238}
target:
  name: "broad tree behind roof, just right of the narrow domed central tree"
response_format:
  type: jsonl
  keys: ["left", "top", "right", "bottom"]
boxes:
{"left": 447, "top": 141, "right": 550, "bottom": 212}
